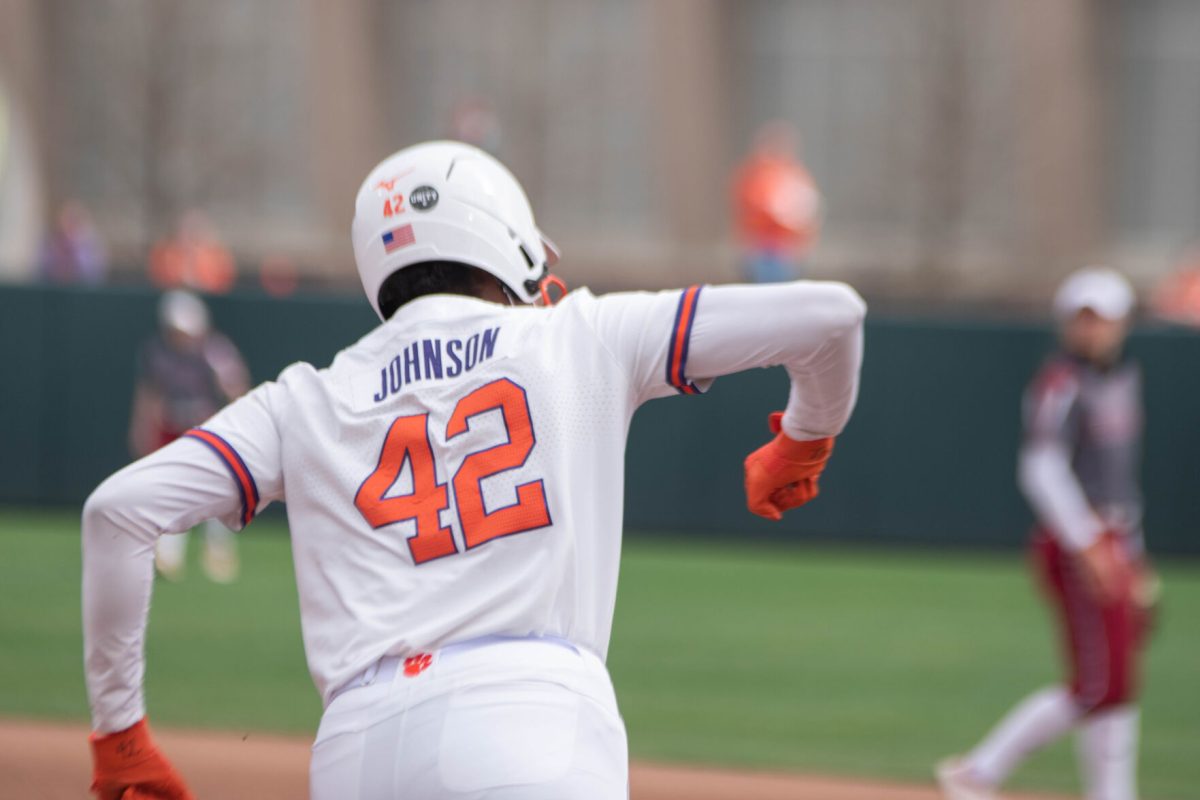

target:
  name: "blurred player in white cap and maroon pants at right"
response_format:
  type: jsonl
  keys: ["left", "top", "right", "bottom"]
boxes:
{"left": 937, "top": 267, "right": 1157, "bottom": 800}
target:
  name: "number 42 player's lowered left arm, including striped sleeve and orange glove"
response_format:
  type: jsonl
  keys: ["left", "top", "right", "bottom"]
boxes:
{"left": 82, "top": 376, "right": 283, "bottom": 800}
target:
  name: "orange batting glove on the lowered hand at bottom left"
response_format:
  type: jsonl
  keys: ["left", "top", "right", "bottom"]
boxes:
{"left": 88, "top": 718, "right": 196, "bottom": 800}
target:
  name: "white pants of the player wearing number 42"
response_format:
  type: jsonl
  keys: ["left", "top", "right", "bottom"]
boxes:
{"left": 311, "top": 639, "right": 629, "bottom": 800}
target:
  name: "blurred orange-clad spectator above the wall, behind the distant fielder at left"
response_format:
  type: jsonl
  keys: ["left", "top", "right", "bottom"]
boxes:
{"left": 149, "top": 209, "right": 238, "bottom": 294}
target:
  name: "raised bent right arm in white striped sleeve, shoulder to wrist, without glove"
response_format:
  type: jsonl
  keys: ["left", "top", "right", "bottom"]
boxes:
{"left": 586, "top": 281, "right": 866, "bottom": 439}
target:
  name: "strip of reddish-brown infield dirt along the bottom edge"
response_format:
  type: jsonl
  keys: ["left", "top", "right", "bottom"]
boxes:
{"left": 0, "top": 720, "right": 1070, "bottom": 800}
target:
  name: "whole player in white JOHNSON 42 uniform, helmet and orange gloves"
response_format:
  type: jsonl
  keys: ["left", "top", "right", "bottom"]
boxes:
{"left": 83, "top": 142, "right": 865, "bottom": 800}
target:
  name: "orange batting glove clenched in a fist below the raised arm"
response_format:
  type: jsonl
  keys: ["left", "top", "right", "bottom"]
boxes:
{"left": 745, "top": 411, "right": 833, "bottom": 521}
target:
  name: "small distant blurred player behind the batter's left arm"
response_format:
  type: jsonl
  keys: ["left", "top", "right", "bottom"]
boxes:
{"left": 130, "top": 290, "right": 250, "bottom": 583}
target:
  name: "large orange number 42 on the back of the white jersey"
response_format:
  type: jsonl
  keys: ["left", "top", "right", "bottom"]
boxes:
{"left": 354, "top": 378, "right": 551, "bottom": 564}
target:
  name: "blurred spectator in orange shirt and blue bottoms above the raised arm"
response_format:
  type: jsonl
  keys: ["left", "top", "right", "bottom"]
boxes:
{"left": 733, "top": 120, "right": 821, "bottom": 283}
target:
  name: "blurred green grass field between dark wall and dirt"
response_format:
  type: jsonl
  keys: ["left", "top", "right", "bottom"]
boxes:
{"left": 0, "top": 511, "right": 1200, "bottom": 800}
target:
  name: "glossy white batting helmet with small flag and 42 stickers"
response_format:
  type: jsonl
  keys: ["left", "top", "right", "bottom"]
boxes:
{"left": 352, "top": 142, "right": 558, "bottom": 318}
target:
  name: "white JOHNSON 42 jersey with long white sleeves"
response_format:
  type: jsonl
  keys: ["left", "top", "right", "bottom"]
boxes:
{"left": 84, "top": 283, "right": 863, "bottom": 730}
